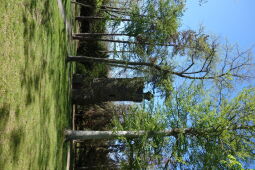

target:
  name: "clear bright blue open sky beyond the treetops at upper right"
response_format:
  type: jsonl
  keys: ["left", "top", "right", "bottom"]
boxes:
{"left": 182, "top": 0, "right": 255, "bottom": 168}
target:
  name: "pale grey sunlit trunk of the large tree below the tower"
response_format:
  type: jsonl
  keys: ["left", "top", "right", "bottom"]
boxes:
{"left": 64, "top": 128, "right": 196, "bottom": 140}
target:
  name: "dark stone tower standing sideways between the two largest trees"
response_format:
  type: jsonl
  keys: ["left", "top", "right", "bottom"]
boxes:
{"left": 72, "top": 74, "right": 152, "bottom": 105}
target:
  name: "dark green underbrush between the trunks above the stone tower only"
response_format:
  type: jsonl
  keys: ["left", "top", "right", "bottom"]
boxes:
{"left": 76, "top": 0, "right": 109, "bottom": 78}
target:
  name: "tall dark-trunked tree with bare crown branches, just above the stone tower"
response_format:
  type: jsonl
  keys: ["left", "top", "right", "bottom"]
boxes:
{"left": 67, "top": 40, "right": 251, "bottom": 81}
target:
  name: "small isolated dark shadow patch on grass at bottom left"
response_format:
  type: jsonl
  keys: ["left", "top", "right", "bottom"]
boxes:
{"left": 10, "top": 129, "right": 24, "bottom": 163}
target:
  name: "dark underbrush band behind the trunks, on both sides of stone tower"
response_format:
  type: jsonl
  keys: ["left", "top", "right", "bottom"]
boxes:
{"left": 71, "top": 0, "right": 119, "bottom": 169}
